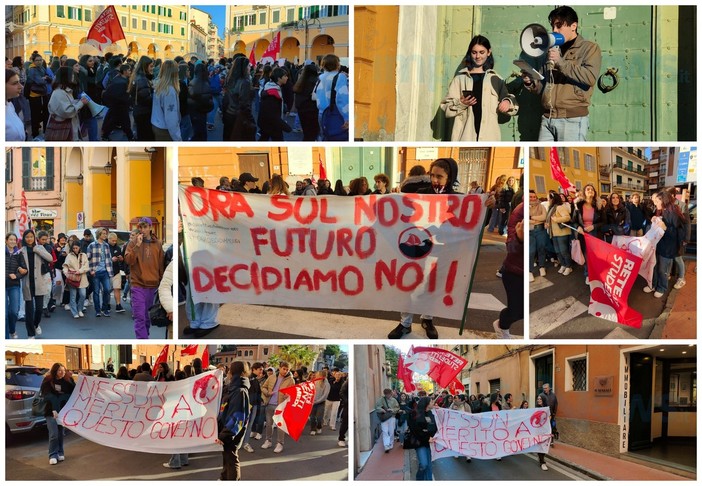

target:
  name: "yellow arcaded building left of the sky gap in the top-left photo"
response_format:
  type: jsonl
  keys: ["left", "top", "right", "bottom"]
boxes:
{"left": 5, "top": 5, "right": 209, "bottom": 59}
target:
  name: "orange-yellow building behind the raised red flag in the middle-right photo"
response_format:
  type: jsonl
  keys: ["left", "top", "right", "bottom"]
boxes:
{"left": 529, "top": 147, "right": 600, "bottom": 198}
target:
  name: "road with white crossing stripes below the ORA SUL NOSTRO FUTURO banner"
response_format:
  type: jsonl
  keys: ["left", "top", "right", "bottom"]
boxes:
{"left": 178, "top": 234, "right": 524, "bottom": 339}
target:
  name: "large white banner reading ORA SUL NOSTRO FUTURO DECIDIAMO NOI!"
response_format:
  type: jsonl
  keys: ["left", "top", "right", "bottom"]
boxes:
{"left": 179, "top": 186, "right": 487, "bottom": 319}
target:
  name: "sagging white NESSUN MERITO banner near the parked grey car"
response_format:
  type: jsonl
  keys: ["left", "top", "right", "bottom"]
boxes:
{"left": 58, "top": 370, "right": 222, "bottom": 454}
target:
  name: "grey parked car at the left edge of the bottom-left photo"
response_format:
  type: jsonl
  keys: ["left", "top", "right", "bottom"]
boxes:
{"left": 5, "top": 366, "right": 47, "bottom": 438}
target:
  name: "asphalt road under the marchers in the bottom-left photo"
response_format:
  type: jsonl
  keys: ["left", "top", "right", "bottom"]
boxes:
{"left": 5, "top": 429, "right": 348, "bottom": 481}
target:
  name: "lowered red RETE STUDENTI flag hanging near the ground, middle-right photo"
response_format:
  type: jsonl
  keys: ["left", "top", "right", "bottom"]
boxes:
{"left": 585, "top": 234, "right": 643, "bottom": 329}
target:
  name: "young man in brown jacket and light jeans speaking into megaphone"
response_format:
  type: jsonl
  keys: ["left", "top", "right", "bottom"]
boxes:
{"left": 522, "top": 6, "right": 602, "bottom": 142}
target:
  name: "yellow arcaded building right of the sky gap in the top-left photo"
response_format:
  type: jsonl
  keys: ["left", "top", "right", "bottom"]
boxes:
{"left": 224, "top": 5, "right": 349, "bottom": 65}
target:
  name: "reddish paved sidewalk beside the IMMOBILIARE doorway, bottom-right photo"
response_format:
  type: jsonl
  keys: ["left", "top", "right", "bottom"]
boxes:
{"left": 546, "top": 442, "right": 689, "bottom": 481}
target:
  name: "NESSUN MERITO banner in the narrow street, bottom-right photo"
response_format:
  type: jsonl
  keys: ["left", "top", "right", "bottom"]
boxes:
{"left": 431, "top": 407, "right": 551, "bottom": 461}
